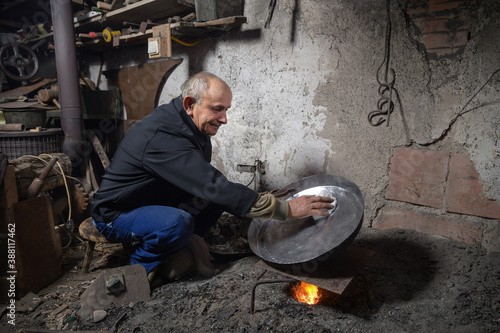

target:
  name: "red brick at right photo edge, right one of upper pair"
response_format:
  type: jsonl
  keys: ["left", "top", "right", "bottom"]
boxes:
{"left": 445, "top": 154, "right": 500, "bottom": 219}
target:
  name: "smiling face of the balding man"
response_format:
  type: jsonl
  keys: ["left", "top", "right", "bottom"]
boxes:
{"left": 184, "top": 79, "right": 233, "bottom": 135}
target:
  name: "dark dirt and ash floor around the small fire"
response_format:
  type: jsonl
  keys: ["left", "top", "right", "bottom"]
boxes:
{"left": 0, "top": 217, "right": 500, "bottom": 333}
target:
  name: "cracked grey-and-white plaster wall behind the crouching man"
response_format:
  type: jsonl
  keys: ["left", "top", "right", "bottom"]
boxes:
{"left": 91, "top": 0, "right": 500, "bottom": 233}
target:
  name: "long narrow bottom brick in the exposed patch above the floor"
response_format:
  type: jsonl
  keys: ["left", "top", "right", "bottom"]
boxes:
{"left": 373, "top": 207, "right": 484, "bottom": 245}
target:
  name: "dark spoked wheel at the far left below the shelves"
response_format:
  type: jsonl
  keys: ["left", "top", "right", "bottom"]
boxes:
{"left": 0, "top": 43, "right": 39, "bottom": 81}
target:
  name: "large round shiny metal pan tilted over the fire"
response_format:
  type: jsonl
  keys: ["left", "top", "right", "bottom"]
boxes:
{"left": 248, "top": 175, "right": 364, "bottom": 266}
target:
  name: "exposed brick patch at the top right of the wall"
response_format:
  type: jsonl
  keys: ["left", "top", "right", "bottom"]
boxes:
{"left": 406, "top": 0, "right": 477, "bottom": 57}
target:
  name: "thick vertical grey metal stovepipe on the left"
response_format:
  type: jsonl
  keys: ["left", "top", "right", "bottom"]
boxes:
{"left": 50, "top": 0, "right": 85, "bottom": 175}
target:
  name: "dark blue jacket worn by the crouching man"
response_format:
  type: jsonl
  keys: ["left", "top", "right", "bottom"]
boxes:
{"left": 92, "top": 97, "right": 257, "bottom": 223}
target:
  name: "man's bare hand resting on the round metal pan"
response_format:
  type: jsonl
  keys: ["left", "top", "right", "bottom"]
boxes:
{"left": 288, "top": 195, "right": 333, "bottom": 219}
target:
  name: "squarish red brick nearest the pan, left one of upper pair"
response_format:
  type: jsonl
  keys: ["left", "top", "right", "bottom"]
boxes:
{"left": 386, "top": 148, "right": 449, "bottom": 208}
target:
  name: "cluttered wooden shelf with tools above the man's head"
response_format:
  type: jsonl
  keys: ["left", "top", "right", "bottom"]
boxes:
{"left": 71, "top": 0, "right": 247, "bottom": 48}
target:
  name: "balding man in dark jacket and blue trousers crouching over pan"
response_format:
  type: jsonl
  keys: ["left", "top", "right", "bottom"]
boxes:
{"left": 92, "top": 72, "right": 332, "bottom": 277}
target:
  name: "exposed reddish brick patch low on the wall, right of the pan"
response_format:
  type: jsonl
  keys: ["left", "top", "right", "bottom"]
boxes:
{"left": 373, "top": 148, "right": 500, "bottom": 245}
